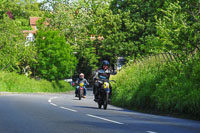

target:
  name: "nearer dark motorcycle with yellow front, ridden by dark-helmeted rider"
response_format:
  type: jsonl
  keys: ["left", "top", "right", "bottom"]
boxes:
{"left": 97, "top": 80, "right": 115, "bottom": 109}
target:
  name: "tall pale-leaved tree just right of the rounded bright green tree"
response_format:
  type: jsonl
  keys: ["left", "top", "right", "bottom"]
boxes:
{"left": 42, "top": 2, "right": 99, "bottom": 75}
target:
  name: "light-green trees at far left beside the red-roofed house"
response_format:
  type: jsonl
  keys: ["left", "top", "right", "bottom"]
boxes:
{"left": 0, "top": 0, "right": 42, "bottom": 74}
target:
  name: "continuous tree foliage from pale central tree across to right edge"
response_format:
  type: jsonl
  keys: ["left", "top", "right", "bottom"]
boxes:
{"left": 42, "top": 0, "right": 199, "bottom": 73}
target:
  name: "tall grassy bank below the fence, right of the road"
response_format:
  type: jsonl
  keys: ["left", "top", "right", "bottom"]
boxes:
{"left": 112, "top": 53, "right": 200, "bottom": 120}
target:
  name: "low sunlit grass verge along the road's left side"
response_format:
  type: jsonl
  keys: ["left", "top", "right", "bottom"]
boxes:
{"left": 0, "top": 71, "right": 74, "bottom": 92}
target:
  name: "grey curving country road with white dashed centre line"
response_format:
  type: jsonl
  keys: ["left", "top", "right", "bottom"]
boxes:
{"left": 0, "top": 91, "right": 200, "bottom": 133}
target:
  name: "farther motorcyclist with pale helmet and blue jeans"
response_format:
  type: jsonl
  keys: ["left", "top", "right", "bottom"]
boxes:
{"left": 75, "top": 73, "right": 89, "bottom": 98}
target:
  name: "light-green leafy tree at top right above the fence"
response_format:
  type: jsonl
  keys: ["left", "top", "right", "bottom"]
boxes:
{"left": 152, "top": 0, "right": 200, "bottom": 56}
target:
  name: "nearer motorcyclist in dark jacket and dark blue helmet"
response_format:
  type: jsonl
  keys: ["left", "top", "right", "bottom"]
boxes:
{"left": 93, "top": 60, "right": 112, "bottom": 101}
